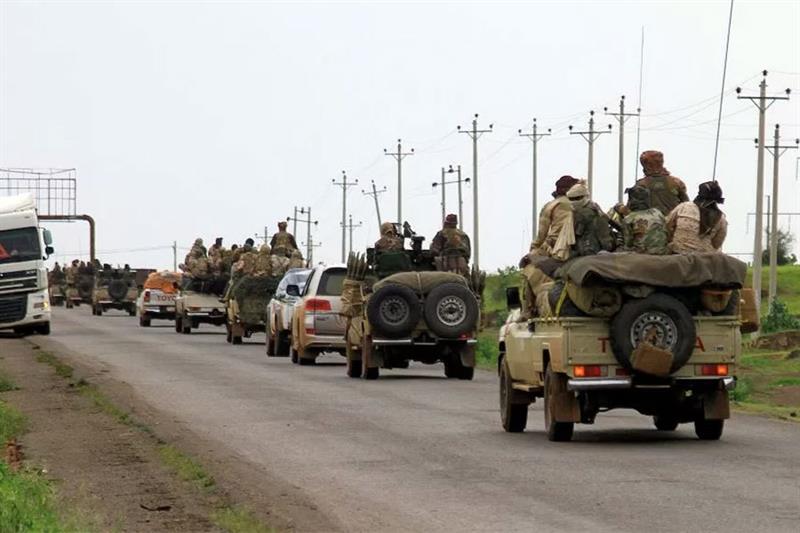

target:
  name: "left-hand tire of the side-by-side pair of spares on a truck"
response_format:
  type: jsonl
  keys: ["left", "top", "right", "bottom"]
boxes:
{"left": 367, "top": 284, "right": 422, "bottom": 339}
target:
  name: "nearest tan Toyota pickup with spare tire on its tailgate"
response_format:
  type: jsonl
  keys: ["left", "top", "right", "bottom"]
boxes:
{"left": 498, "top": 254, "right": 749, "bottom": 441}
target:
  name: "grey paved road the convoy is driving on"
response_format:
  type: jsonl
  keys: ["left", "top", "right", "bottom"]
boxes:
{"left": 32, "top": 307, "right": 800, "bottom": 532}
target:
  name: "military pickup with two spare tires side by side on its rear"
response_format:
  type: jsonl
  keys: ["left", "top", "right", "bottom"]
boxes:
{"left": 343, "top": 223, "right": 484, "bottom": 380}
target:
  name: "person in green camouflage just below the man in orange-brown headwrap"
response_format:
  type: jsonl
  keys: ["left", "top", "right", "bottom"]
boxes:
{"left": 622, "top": 185, "right": 669, "bottom": 255}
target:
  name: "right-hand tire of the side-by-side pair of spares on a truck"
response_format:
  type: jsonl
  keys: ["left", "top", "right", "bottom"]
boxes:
{"left": 424, "top": 283, "right": 480, "bottom": 339}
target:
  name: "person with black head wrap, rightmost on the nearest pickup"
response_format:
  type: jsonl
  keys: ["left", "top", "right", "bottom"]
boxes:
{"left": 667, "top": 181, "right": 728, "bottom": 254}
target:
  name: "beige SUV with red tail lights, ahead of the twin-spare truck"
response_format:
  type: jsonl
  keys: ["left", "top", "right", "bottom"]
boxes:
{"left": 287, "top": 265, "right": 347, "bottom": 365}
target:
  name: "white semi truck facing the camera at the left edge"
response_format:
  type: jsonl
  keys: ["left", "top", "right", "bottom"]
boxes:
{"left": 0, "top": 193, "right": 53, "bottom": 335}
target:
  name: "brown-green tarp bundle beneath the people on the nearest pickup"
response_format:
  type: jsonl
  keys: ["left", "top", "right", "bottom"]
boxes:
{"left": 559, "top": 253, "right": 747, "bottom": 289}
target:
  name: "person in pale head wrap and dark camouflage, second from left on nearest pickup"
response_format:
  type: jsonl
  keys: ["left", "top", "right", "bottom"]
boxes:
{"left": 567, "top": 183, "right": 614, "bottom": 257}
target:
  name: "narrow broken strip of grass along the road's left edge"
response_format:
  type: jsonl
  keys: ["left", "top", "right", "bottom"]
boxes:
{"left": 32, "top": 342, "right": 275, "bottom": 533}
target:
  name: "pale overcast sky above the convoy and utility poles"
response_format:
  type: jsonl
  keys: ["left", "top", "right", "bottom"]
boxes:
{"left": 0, "top": 0, "right": 800, "bottom": 269}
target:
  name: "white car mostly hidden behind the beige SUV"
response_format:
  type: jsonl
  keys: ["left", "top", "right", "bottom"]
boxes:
{"left": 267, "top": 268, "right": 311, "bottom": 357}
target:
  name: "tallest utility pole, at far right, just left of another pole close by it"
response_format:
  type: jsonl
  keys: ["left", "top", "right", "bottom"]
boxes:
{"left": 736, "top": 70, "right": 790, "bottom": 306}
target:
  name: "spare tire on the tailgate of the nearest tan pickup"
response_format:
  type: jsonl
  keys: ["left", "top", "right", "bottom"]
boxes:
{"left": 611, "top": 292, "right": 697, "bottom": 373}
